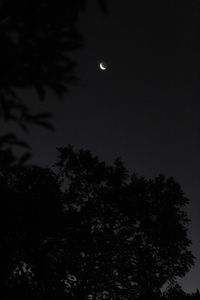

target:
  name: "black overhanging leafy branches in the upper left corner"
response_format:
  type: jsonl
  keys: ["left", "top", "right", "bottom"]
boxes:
{"left": 0, "top": 0, "right": 106, "bottom": 165}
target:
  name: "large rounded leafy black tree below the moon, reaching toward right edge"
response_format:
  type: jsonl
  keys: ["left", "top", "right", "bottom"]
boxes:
{"left": 54, "top": 147, "right": 193, "bottom": 299}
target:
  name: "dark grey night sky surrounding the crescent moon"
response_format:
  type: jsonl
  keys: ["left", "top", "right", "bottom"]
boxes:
{"left": 21, "top": 0, "right": 200, "bottom": 291}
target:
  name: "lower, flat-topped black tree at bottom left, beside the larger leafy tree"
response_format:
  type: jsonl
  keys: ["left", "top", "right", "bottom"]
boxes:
{"left": 0, "top": 167, "right": 62, "bottom": 299}
